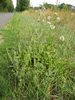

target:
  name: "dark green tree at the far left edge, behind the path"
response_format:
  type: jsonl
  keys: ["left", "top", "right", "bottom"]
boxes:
{"left": 0, "top": 0, "right": 14, "bottom": 12}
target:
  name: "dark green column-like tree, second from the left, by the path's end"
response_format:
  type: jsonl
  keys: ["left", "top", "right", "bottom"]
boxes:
{"left": 16, "top": 0, "right": 30, "bottom": 11}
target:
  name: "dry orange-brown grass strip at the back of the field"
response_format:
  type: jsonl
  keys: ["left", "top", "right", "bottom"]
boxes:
{"left": 22, "top": 9, "right": 75, "bottom": 26}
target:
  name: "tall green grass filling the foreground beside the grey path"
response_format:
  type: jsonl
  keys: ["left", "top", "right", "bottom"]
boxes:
{"left": 0, "top": 13, "right": 75, "bottom": 100}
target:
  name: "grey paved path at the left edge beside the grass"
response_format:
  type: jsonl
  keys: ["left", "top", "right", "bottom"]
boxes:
{"left": 0, "top": 13, "right": 14, "bottom": 29}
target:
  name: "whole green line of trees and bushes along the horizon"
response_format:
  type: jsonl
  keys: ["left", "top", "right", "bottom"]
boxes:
{"left": 0, "top": 0, "right": 75, "bottom": 12}
